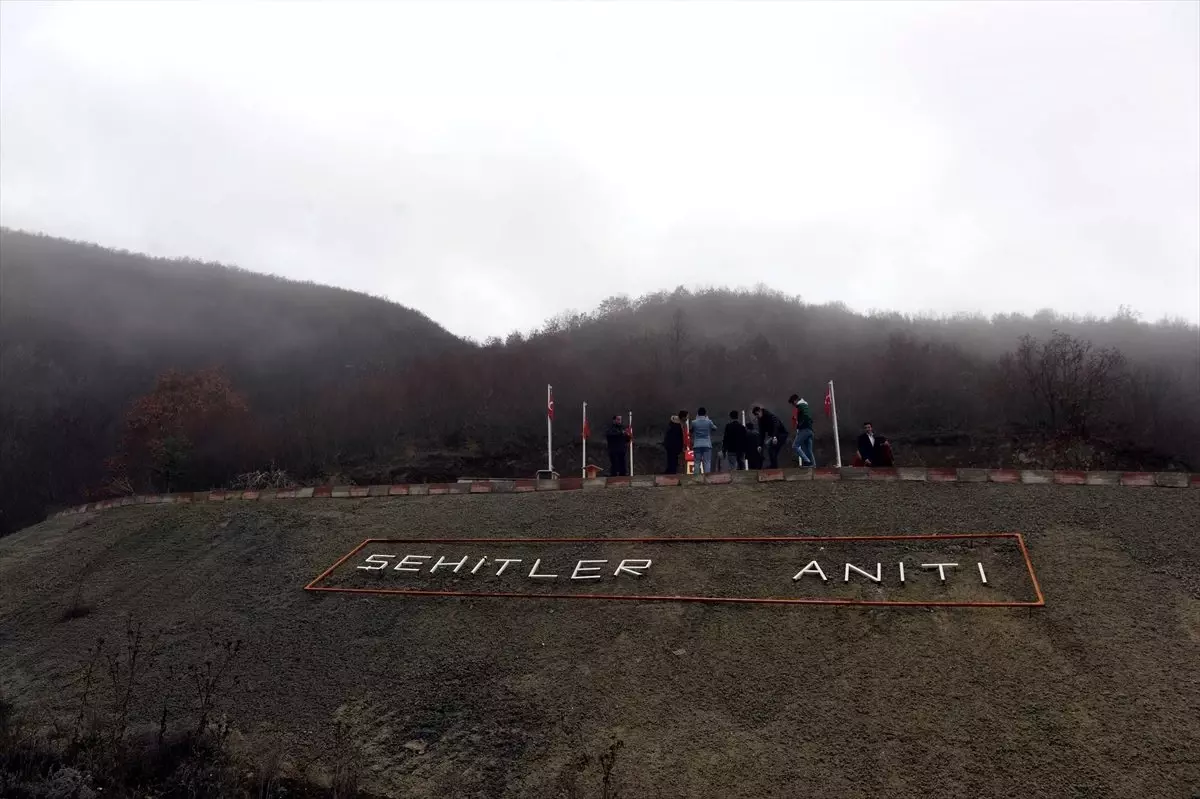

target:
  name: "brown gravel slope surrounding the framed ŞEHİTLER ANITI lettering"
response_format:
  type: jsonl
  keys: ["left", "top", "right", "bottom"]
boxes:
{"left": 0, "top": 483, "right": 1200, "bottom": 799}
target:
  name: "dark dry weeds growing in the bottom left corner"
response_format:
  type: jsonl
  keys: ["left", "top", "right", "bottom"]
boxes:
{"left": 0, "top": 618, "right": 365, "bottom": 799}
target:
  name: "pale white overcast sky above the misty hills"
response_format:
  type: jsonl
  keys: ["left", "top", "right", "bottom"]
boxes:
{"left": 0, "top": 0, "right": 1200, "bottom": 338}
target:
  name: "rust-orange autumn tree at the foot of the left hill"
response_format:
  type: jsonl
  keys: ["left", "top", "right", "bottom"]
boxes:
{"left": 109, "top": 368, "right": 250, "bottom": 491}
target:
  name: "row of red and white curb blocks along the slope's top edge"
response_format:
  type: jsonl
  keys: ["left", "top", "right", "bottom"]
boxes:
{"left": 48, "top": 467, "right": 1200, "bottom": 518}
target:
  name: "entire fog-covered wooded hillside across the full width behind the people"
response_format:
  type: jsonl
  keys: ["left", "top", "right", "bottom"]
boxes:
{"left": 0, "top": 230, "right": 1200, "bottom": 530}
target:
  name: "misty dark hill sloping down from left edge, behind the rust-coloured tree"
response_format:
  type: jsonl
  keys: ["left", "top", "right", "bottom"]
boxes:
{"left": 0, "top": 229, "right": 469, "bottom": 531}
